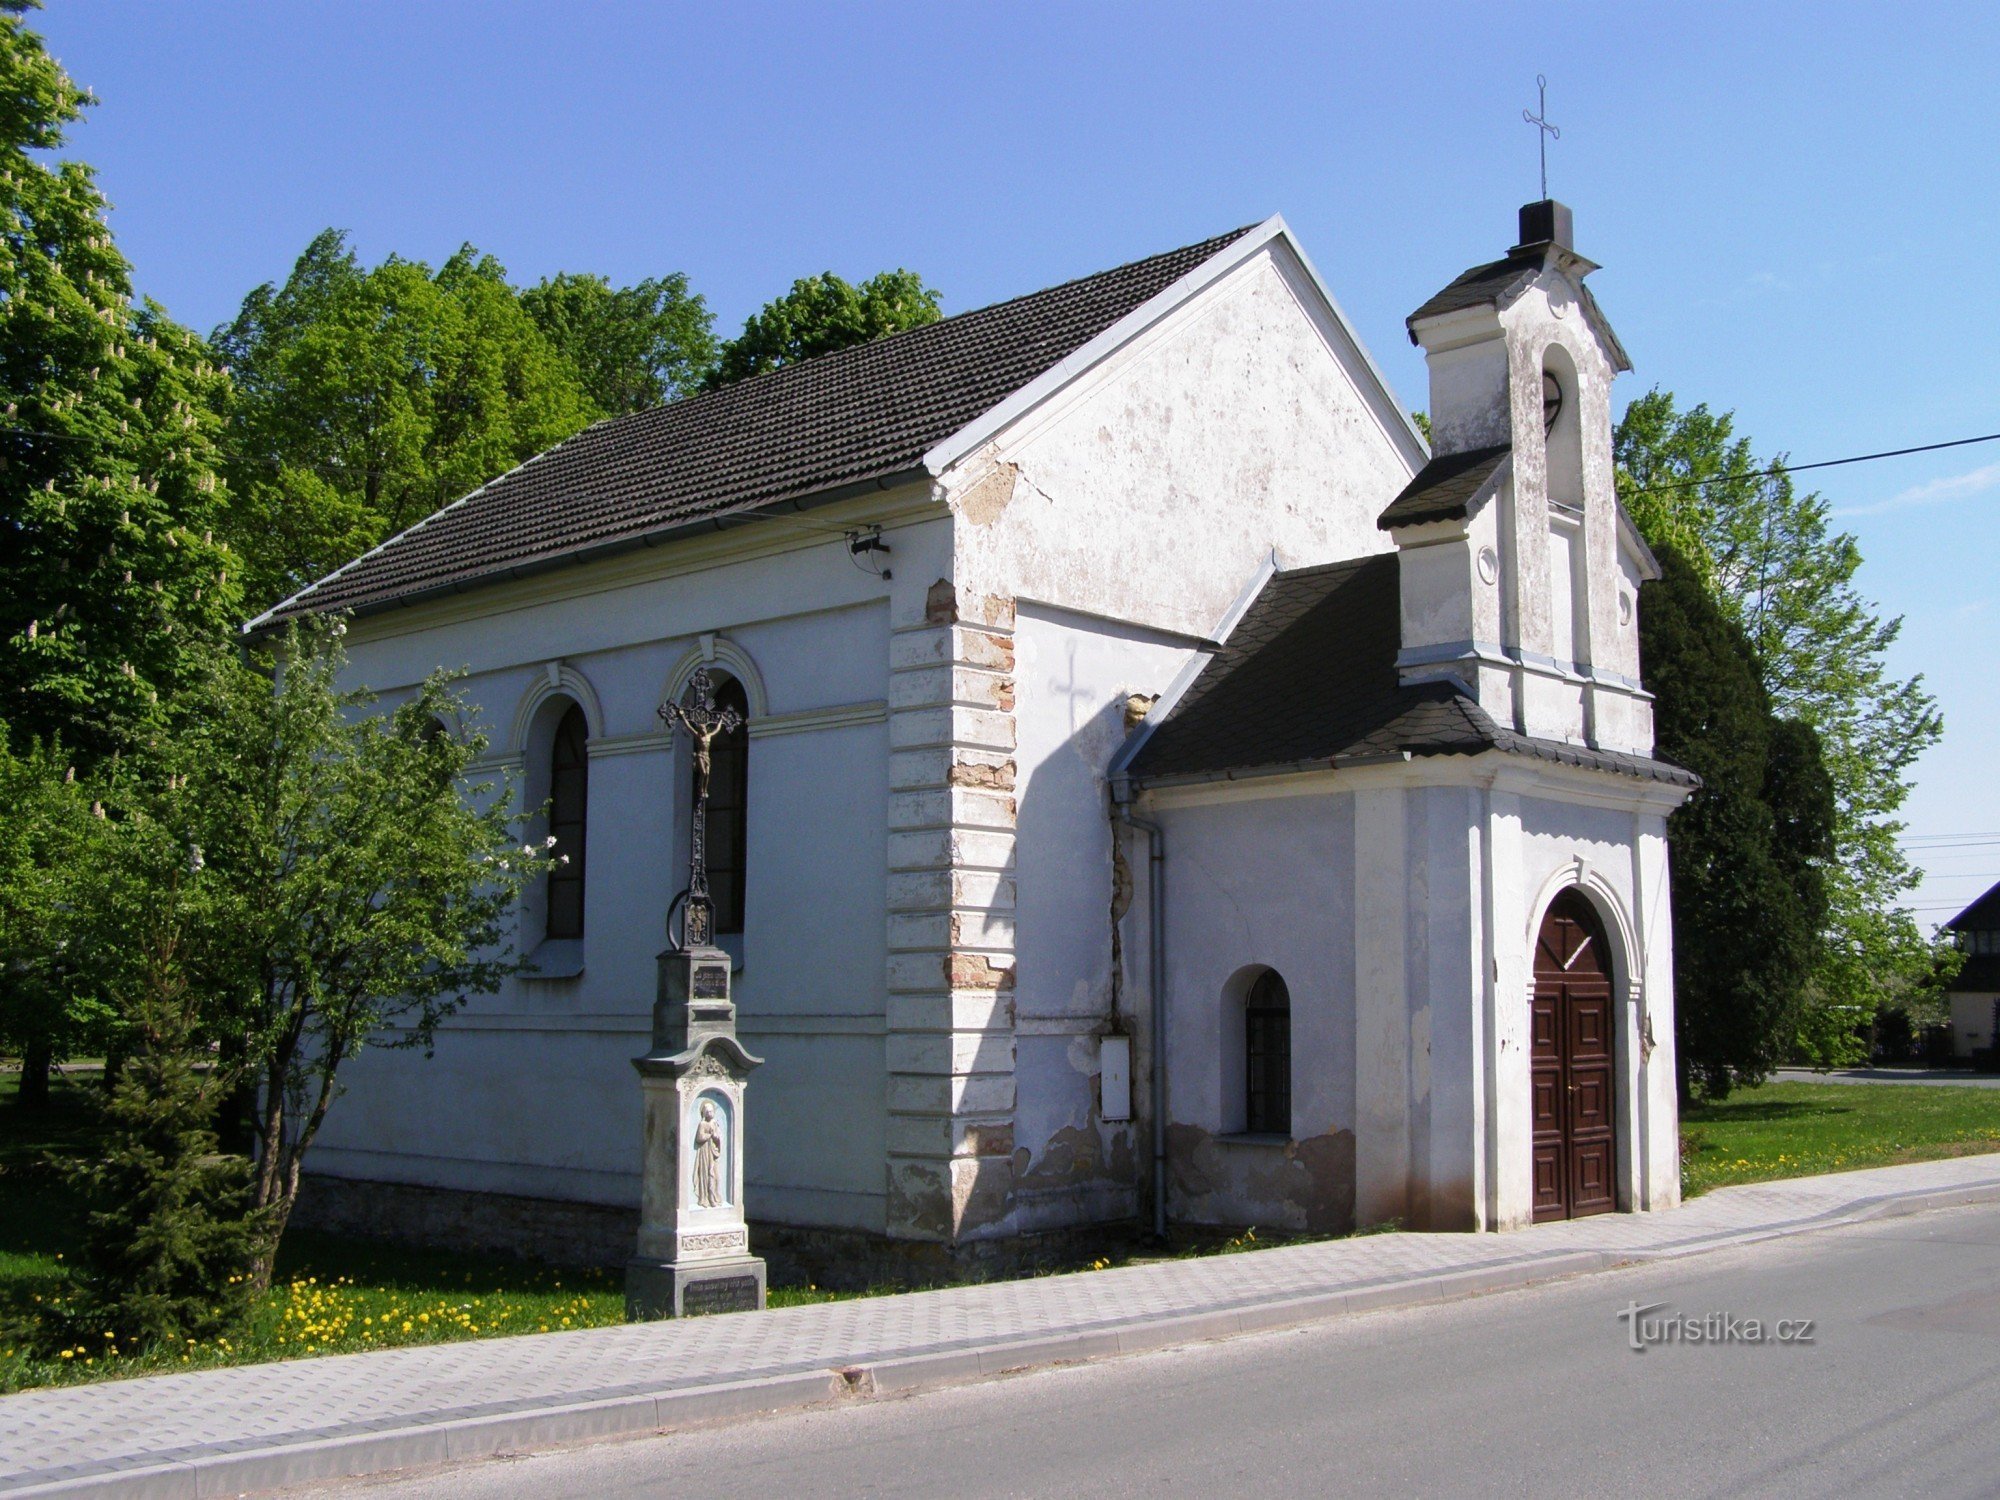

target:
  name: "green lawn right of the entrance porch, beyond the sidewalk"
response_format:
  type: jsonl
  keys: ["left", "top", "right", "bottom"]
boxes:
{"left": 1680, "top": 1084, "right": 2000, "bottom": 1198}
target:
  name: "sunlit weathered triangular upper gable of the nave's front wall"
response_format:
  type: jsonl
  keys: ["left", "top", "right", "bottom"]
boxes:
{"left": 942, "top": 240, "right": 1422, "bottom": 636}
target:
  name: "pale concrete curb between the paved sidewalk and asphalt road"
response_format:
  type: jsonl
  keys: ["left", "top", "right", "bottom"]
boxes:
{"left": 15, "top": 1182, "right": 2000, "bottom": 1500}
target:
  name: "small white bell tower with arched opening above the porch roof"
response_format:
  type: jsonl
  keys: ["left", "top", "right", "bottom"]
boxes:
{"left": 1380, "top": 198, "right": 1656, "bottom": 754}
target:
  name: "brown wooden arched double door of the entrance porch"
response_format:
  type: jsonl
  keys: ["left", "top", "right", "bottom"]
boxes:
{"left": 1530, "top": 890, "right": 1618, "bottom": 1224}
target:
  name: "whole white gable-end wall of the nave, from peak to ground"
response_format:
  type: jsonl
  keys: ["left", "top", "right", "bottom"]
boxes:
{"left": 940, "top": 238, "right": 1422, "bottom": 1230}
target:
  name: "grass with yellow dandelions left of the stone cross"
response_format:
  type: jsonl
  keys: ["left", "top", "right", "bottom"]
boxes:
{"left": 0, "top": 1074, "right": 838, "bottom": 1392}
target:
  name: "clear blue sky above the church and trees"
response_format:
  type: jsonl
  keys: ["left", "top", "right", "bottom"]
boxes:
{"left": 34, "top": 0, "right": 2000, "bottom": 920}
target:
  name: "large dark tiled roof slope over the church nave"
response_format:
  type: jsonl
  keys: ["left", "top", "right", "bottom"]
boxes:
{"left": 268, "top": 226, "right": 1248, "bottom": 620}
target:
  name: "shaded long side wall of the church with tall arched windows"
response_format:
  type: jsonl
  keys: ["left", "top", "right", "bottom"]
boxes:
{"left": 312, "top": 494, "right": 950, "bottom": 1230}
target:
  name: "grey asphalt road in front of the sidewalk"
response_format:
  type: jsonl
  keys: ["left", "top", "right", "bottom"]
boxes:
{"left": 310, "top": 1206, "right": 2000, "bottom": 1500}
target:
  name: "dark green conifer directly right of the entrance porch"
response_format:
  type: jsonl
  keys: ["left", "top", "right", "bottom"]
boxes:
{"left": 1640, "top": 546, "right": 1834, "bottom": 1098}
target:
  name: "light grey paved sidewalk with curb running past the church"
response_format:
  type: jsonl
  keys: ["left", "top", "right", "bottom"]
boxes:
{"left": 0, "top": 1156, "right": 2000, "bottom": 1500}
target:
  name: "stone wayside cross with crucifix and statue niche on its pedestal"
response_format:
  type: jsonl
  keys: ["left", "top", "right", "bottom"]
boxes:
{"left": 626, "top": 668, "right": 764, "bottom": 1322}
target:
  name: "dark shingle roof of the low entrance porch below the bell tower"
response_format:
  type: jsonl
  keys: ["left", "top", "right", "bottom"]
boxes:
{"left": 1130, "top": 552, "right": 1698, "bottom": 786}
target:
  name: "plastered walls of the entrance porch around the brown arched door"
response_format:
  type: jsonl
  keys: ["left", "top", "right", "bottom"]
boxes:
{"left": 1148, "top": 756, "right": 1680, "bottom": 1230}
